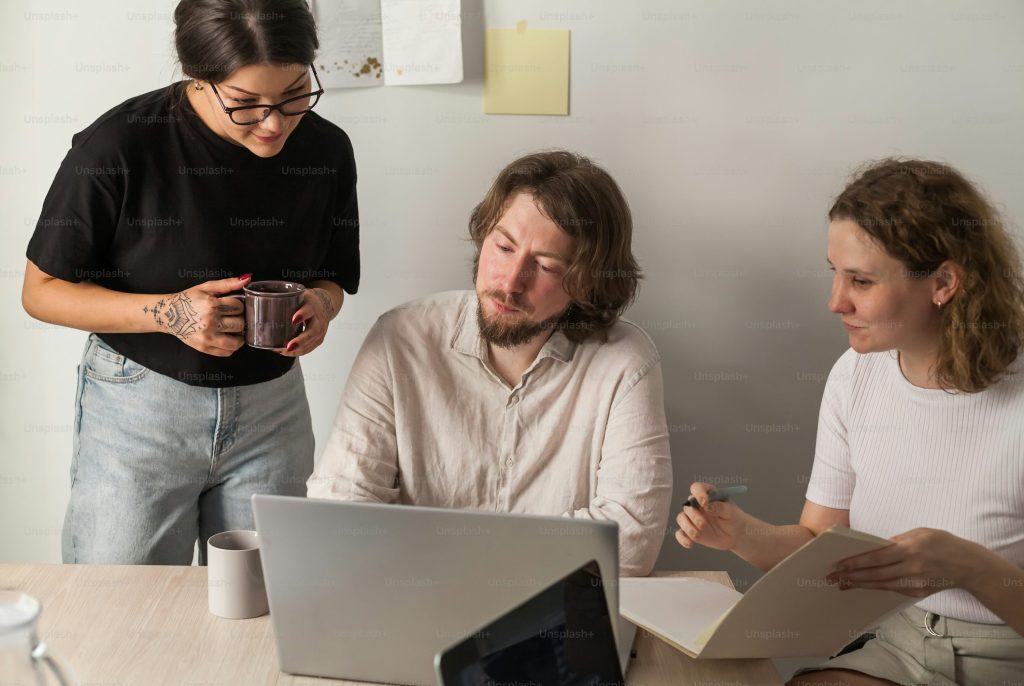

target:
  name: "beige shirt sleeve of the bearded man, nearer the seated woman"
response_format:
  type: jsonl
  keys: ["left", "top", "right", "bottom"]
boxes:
{"left": 566, "top": 361, "right": 672, "bottom": 576}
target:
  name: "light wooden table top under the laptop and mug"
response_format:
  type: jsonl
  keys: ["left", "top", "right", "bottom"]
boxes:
{"left": 0, "top": 564, "right": 781, "bottom": 686}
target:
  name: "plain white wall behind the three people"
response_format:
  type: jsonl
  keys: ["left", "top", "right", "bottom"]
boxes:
{"left": 0, "top": 0, "right": 1024, "bottom": 602}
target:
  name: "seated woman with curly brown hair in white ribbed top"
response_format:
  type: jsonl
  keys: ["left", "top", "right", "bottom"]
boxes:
{"left": 676, "top": 160, "right": 1024, "bottom": 686}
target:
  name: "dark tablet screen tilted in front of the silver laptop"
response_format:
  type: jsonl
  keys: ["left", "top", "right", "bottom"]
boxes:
{"left": 437, "top": 561, "right": 624, "bottom": 686}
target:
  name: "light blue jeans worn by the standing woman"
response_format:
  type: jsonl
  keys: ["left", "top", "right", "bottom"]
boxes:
{"left": 61, "top": 334, "right": 313, "bottom": 564}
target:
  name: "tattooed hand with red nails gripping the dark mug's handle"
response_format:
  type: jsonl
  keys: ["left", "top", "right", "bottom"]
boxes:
{"left": 142, "top": 274, "right": 252, "bottom": 357}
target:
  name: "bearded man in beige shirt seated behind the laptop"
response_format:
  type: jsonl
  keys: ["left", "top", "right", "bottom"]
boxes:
{"left": 307, "top": 151, "right": 672, "bottom": 575}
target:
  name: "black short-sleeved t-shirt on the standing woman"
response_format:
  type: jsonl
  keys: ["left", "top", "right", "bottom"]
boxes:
{"left": 28, "top": 83, "right": 359, "bottom": 387}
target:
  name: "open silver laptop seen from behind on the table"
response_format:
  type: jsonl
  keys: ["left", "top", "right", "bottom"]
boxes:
{"left": 252, "top": 495, "right": 633, "bottom": 684}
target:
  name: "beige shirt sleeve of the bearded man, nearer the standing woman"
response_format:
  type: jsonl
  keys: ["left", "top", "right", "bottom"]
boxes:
{"left": 306, "top": 319, "right": 398, "bottom": 503}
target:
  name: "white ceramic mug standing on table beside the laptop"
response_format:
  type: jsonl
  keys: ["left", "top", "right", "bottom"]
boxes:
{"left": 206, "top": 530, "right": 267, "bottom": 619}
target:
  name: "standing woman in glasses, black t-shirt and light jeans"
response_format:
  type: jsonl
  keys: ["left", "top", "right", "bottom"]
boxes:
{"left": 23, "top": 0, "right": 359, "bottom": 564}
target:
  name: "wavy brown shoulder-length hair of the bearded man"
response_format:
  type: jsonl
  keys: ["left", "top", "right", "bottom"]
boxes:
{"left": 469, "top": 151, "right": 641, "bottom": 343}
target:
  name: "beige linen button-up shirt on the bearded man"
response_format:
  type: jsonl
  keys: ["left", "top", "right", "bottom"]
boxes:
{"left": 307, "top": 291, "right": 672, "bottom": 575}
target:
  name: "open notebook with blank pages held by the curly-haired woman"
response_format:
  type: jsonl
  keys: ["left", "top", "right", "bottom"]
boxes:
{"left": 618, "top": 526, "right": 914, "bottom": 657}
